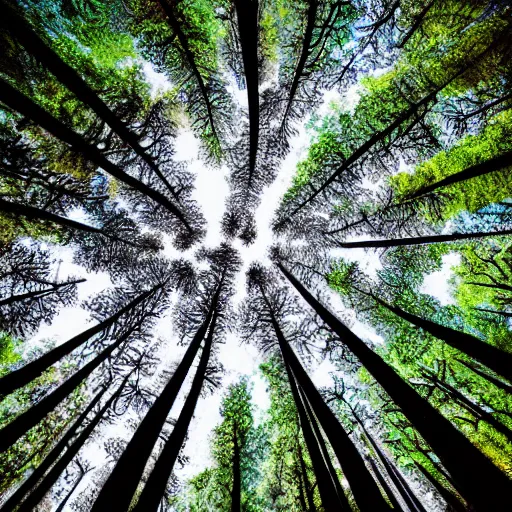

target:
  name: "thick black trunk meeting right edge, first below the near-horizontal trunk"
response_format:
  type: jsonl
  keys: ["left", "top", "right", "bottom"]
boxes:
{"left": 362, "top": 292, "right": 512, "bottom": 380}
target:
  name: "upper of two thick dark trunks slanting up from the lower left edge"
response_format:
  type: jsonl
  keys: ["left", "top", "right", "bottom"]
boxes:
{"left": 0, "top": 284, "right": 158, "bottom": 397}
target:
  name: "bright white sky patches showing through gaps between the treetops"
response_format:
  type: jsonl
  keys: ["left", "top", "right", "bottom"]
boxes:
{"left": 17, "top": 63, "right": 457, "bottom": 510}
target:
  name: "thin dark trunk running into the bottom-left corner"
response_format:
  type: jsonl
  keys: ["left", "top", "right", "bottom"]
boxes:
{"left": 1, "top": 386, "right": 107, "bottom": 512}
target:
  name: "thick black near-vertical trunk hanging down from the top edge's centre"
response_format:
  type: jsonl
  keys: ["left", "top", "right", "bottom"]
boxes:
{"left": 234, "top": 0, "right": 260, "bottom": 178}
